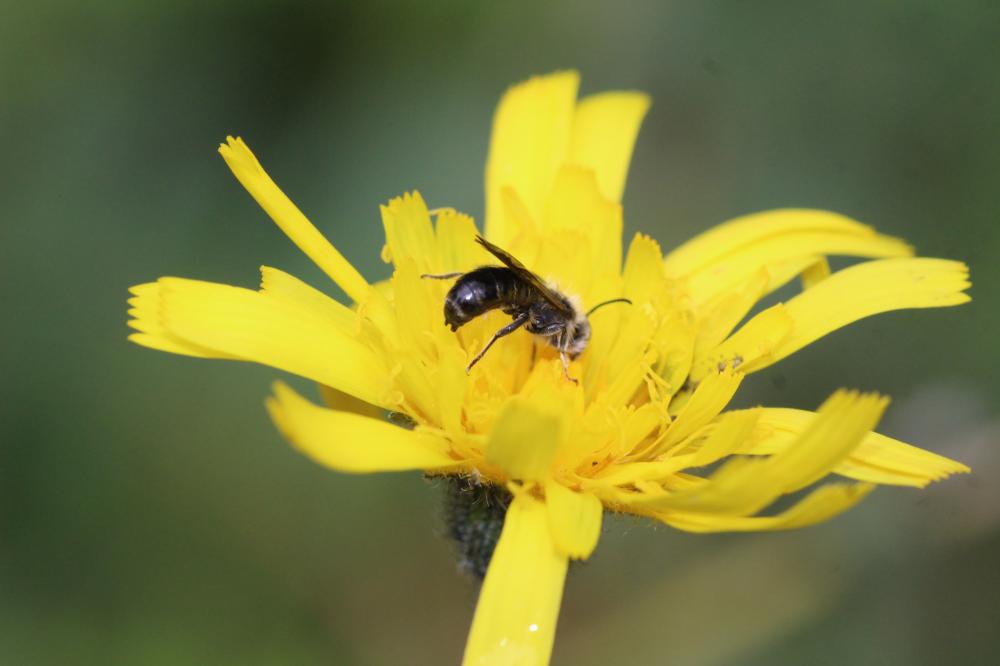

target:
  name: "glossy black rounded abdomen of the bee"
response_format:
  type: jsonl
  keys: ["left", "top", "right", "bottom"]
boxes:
{"left": 444, "top": 266, "right": 530, "bottom": 331}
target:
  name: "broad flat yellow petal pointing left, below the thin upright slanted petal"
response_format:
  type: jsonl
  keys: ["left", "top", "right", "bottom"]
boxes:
{"left": 154, "top": 278, "right": 394, "bottom": 409}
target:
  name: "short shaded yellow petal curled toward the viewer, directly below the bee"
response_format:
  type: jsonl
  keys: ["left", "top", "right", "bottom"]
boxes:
{"left": 486, "top": 396, "right": 563, "bottom": 481}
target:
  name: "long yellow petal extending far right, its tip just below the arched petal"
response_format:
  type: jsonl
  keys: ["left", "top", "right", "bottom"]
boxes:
{"left": 733, "top": 258, "right": 969, "bottom": 372}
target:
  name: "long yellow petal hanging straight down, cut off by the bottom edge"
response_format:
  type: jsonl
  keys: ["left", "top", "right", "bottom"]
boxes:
{"left": 462, "top": 492, "right": 567, "bottom": 666}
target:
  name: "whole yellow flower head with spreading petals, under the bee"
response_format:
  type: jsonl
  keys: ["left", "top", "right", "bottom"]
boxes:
{"left": 130, "top": 72, "right": 969, "bottom": 664}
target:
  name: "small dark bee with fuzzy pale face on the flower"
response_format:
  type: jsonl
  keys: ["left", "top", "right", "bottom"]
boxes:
{"left": 420, "top": 236, "right": 631, "bottom": 384}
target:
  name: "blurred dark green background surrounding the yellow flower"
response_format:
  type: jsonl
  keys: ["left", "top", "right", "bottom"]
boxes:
{"left": 0, "top": 0, "right": 1000, "bottom": 665}
